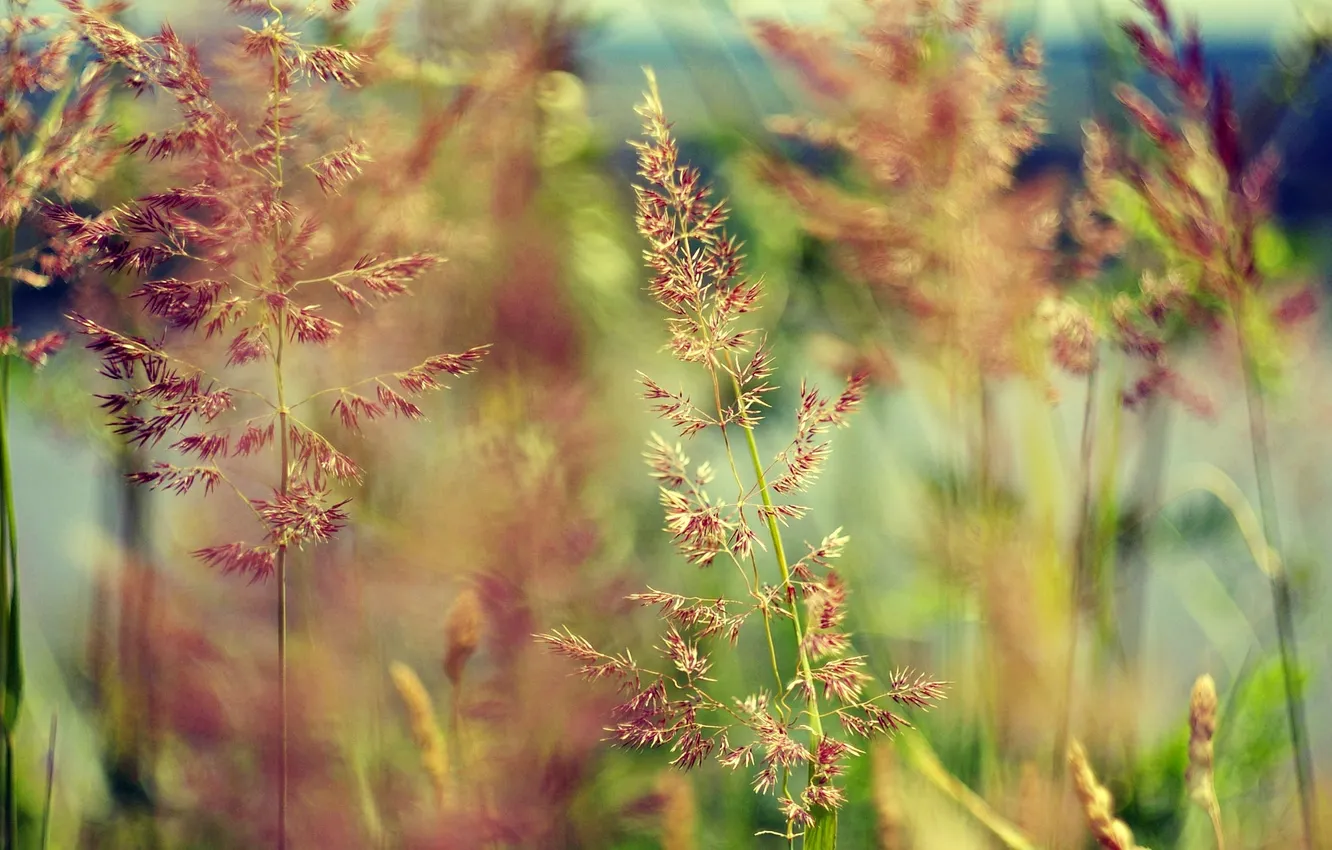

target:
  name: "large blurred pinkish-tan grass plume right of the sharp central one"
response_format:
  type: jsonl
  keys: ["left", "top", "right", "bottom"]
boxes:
{"left": 757, "top": 0, "right": 1059, "bottom": 380}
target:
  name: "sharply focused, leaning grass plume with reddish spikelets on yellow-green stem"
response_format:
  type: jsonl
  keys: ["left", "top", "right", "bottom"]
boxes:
{"left": 537, "top": 71, "right": 944, "bottom": 849}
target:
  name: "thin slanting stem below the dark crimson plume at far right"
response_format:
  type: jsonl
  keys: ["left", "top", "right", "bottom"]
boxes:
{"left": 1233, "top": 298, "right": 1319, "bottom": 850}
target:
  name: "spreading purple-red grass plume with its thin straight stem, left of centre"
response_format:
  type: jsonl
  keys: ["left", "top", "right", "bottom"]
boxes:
{"left": 57, "top": 0, "right": 488, "bottom": 850}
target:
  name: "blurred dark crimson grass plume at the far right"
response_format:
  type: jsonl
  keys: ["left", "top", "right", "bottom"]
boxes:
{"left": 1074, "top": 0, "right": 1316, "bottom": 414}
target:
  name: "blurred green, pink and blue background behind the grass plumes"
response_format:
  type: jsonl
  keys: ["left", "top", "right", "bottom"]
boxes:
{"left": 11, "top": 0, "right": 1332, "bottom": 850}
